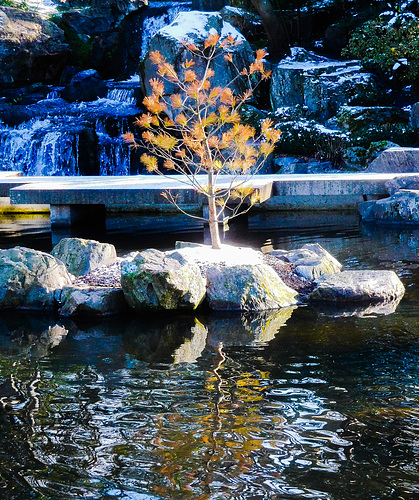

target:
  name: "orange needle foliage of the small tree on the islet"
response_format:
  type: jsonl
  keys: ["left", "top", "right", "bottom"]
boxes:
{"left": 125, "top": 33, "right": 281, "bottom": 188}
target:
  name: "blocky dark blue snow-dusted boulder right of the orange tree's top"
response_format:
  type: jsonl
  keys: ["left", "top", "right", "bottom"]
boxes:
{"left": 271, "top": 47, "right": 378, "bottom": 120}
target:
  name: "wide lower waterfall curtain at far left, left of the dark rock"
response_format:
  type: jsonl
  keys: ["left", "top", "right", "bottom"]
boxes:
{"left": 0, "top": 119, "right": 79, "bottom": 175}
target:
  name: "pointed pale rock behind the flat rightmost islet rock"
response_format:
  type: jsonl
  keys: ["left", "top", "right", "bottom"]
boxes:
{"left": 270, "top": 243, "right": 342, "bottom": 280}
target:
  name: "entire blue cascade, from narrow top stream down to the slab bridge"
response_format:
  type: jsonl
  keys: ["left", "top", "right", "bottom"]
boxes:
{"left": 0, "top": 0, "right": 191, "bottom": 176}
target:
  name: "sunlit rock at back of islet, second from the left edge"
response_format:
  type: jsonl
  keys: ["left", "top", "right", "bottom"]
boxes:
{"left": 51, "top": 238, "right": 116, "bottom": 276}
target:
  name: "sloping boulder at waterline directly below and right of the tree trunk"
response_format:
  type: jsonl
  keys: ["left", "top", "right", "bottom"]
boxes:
{"left": 207, "top": 264, "right": 298, "bottom": 311}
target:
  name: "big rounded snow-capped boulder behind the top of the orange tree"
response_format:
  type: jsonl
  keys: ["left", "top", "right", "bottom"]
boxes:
{"left": 140, "top": 11, "right": 252, "bottom": 103}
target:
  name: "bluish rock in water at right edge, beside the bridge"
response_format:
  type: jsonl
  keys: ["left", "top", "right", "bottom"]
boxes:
{"left": 359, "top": 189, "right": 419, "bottom": 224}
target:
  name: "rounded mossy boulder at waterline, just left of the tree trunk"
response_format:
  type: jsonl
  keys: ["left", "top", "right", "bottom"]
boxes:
{"left": 121, "top": 249, "right": 205, "bottom": 311}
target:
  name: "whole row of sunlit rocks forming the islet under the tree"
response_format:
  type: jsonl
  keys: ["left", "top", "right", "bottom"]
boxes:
{"left": 0, "top": 238, "right": 404, "bottom": 317}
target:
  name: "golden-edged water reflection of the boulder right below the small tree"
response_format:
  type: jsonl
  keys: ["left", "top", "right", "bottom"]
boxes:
{"left": 207, "top": 307, "right": 294, "bottom": 346}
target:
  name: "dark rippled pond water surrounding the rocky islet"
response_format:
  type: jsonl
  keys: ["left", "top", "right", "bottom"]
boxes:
{"left": 0, "top": 209, "right": 419, "bottom": 500}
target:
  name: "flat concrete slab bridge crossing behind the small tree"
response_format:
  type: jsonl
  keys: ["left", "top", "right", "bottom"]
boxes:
{"left": 0, "top": 172, "right": 417, "bottom": 226}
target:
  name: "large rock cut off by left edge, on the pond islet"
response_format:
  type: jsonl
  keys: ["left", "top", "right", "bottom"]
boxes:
{"left": 0, "top": 247, "right": 71, "bottom": 310}
